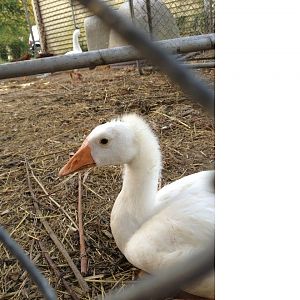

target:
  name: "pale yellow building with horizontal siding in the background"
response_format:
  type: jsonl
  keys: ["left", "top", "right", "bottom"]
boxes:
{"left": 32, "top": 0, "right": 214, "bottom": 54}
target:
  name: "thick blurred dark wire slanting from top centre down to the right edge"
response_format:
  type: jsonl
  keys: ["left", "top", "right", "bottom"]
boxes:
{"left": 78, "top": 0, "right": 215, "bottom": 115}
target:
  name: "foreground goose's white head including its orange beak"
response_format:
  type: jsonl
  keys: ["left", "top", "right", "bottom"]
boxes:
{"left": 59, "top": 120, "right": 138, "bottom": 176}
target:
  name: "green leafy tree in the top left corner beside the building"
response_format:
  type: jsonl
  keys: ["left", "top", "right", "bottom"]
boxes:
{"left": 0, "top": 0, "right": 34, "bottom": 58}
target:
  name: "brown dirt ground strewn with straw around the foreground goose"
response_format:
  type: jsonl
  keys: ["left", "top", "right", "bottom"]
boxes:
{"left": 0, "top": 67, "right": 214, "bottom": 299}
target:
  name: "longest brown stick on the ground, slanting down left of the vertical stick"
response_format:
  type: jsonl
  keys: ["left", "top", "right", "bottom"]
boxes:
{"left": 25, "top": 160, "right": 89, "bottom": 293}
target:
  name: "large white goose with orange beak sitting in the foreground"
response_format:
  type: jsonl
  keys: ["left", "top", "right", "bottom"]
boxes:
{"left": 59, "top": 114, "right": 215, "bottom": 298}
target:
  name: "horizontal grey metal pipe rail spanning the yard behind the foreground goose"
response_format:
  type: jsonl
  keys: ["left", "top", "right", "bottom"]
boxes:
{"left": 0, "top": 34, "right": 214, "bottom": 79}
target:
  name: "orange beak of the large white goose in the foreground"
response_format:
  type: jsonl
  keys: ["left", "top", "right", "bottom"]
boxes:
{"left": 58, "top": 140, "right": 96, "bottom": 177}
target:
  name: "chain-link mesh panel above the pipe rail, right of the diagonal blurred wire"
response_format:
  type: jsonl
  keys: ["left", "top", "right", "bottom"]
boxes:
{"left": 127, "top": 0, "right": 215, "bottom": 40}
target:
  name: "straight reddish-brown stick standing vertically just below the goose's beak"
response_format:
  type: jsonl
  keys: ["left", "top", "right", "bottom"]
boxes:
{"left": 78, "top": 172, "right": 88, "bottom": 275}
